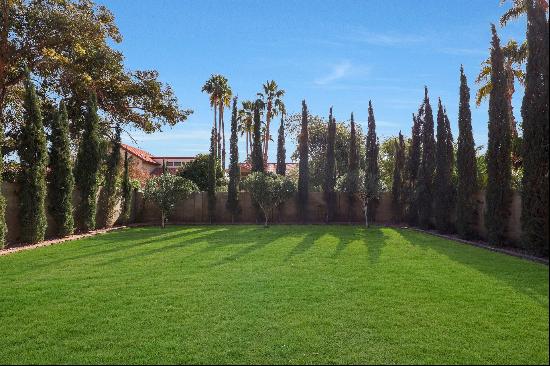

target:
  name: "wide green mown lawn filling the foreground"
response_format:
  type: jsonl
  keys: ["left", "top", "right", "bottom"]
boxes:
{"left": 0, "top": 226, "right": 549, "bottom": 364}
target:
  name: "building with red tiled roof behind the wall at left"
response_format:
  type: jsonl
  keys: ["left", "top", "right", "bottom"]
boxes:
{"left": 121, "top": 144, "right": 195, "bottom": 181}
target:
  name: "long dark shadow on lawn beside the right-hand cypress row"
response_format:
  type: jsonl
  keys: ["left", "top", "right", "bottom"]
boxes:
{"left": 395, "top": 229, "right": 548, "bottom": 306}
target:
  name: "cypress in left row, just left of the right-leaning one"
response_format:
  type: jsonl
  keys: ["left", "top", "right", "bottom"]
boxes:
{"left": 75, "top": 93, "right": 101, "bottom": 232}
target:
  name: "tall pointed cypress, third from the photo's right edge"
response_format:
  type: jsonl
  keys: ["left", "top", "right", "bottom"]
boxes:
{"left": 456, "top": 66, "right": 478, "bottom": 239}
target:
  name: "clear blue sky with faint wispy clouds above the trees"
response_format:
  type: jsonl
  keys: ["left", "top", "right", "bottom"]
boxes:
{"left": 100, "top": 0, "right": 525, "bottom": 161}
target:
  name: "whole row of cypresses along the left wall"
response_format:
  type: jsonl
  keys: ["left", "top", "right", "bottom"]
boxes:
{"left": 0, "top": 70, "right": 131, "bottom": 247}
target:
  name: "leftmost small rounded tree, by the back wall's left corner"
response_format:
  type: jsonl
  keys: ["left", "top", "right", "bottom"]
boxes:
{"left": 143, "top": 173, "right": 198, "bottom": 228}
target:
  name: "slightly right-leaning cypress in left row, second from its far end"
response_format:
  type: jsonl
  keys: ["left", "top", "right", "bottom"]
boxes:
{"left": 97, "top": 126, "right": 121, "bottom": 228}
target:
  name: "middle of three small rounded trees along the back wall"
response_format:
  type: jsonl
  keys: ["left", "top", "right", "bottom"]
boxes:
{"left": 243, "top": 172, "right": 296, "bottom": 227}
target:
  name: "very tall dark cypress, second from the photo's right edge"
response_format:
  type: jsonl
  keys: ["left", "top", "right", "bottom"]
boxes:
{"left": 485, "top": 24, "right": 512, "bottom": 245}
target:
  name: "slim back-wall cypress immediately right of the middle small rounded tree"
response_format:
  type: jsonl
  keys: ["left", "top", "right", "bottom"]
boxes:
{"left": 298, "top": 100, "right": 309, "bottom": 222}
